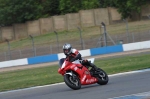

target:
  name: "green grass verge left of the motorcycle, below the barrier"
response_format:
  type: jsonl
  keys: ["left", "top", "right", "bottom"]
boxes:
{"left": 0, "top": 66, "right": 62, "bottom": 91}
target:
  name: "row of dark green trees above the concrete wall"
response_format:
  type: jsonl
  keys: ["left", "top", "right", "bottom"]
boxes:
{"left": 0, "top": 0, "right": 150, "bottom": 26}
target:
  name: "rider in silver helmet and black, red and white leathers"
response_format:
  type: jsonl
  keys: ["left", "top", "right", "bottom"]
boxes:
{"left": 59, "top": 43, "right": 97, "bottom": 70}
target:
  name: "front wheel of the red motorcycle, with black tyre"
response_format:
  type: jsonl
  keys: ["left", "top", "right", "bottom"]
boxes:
{"left": 64, "top": 74, "right": 81, "bottom": 90}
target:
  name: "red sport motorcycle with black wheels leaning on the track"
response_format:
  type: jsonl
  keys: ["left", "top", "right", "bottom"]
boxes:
{"left": 58, "top": 58, "right": 109, "bottom": 90}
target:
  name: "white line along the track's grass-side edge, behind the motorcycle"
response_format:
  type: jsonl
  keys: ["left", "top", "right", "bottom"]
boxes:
{"left": 0, "top": 68, "right": 150, "bottom": 94}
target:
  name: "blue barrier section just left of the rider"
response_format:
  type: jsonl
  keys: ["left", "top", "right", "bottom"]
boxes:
{"left": 28, "top": 54, "right": 58, "bottom": 65}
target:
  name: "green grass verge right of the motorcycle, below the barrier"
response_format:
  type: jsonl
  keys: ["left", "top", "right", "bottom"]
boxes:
{"left": 95, "top": 55, "right": 150, "bottom": 74}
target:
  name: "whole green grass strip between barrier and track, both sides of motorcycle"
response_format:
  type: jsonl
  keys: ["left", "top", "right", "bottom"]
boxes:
{"left": 0, "top": 54, "right": 150, "bottom": 91}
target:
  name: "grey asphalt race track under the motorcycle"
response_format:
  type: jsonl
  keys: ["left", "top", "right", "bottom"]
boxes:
{"left": 0, "top": 69, "right": 150, "bottom": 99}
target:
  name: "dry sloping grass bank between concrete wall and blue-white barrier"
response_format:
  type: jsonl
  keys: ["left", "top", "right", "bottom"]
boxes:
{"left": 0, "top": 20, "right": 150, "bottom": 52}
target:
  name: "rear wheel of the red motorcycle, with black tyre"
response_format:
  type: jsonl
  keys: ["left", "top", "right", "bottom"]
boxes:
{"left": 96, "top": 68, "right": 109, "bottom": 85}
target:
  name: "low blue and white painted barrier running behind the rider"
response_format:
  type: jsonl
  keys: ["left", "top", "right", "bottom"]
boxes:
{"left": 0, "top": 41, "right": 150, "bottom": 68}
